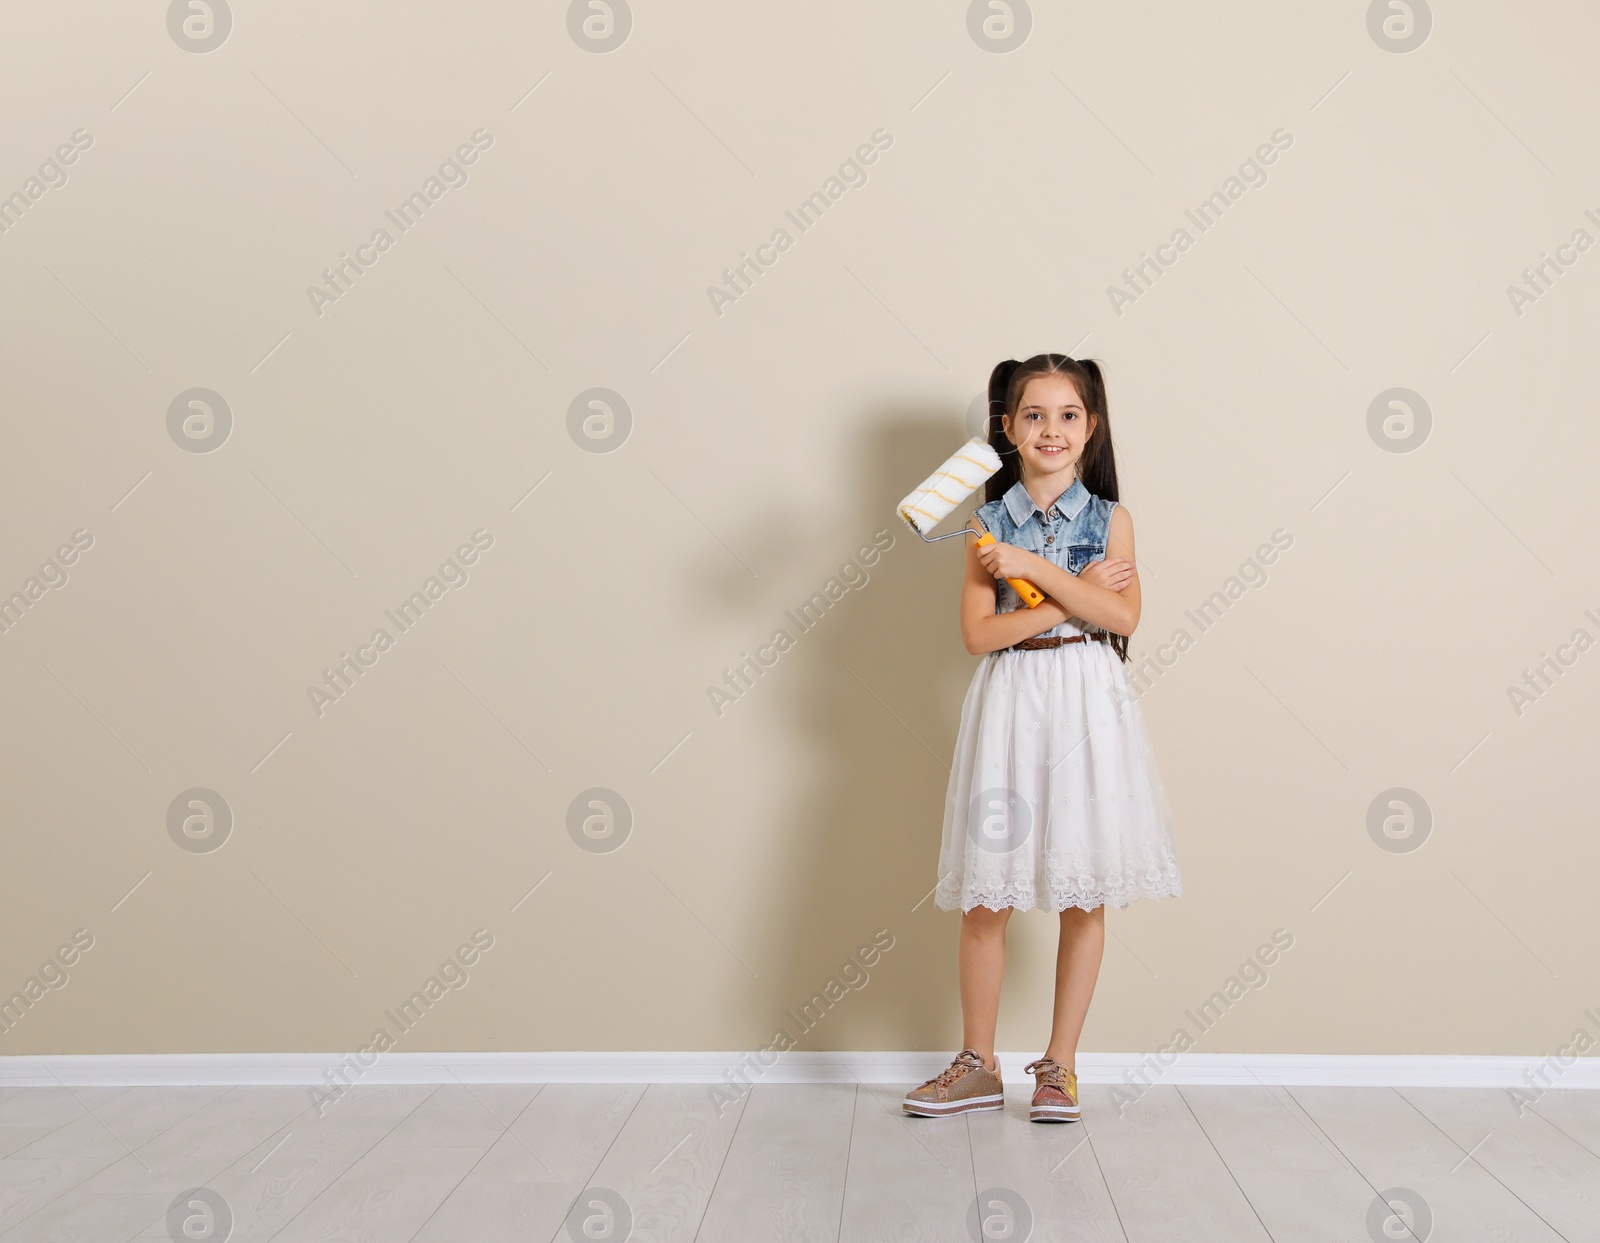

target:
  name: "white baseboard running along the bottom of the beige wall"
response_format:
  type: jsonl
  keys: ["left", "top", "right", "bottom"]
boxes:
{"left": 0, "top": 1051, "right": 1600, "bottom": 1088}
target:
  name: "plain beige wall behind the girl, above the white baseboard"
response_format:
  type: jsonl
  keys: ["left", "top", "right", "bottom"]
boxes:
{"left": 0, "top": 0, "right": 1600, "bottom": 1054}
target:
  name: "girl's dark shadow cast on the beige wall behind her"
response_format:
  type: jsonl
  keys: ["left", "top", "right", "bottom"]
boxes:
{"left": 752, "top": 410, "right": 1032, "bottom": 1049}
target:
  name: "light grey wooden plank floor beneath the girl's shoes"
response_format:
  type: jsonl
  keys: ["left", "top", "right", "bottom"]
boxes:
{"left": 0, "top": 1083, "right": 1600, "bottom": 1243}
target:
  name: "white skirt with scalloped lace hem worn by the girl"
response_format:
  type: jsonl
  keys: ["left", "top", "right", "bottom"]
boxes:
{"left": 934, "top": 640, "right": 1184, "bottom": 910}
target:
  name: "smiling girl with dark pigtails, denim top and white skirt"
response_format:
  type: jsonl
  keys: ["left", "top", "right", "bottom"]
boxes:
{"left": 904, "top": 354, "right": 1182, "bottom": 1121}
